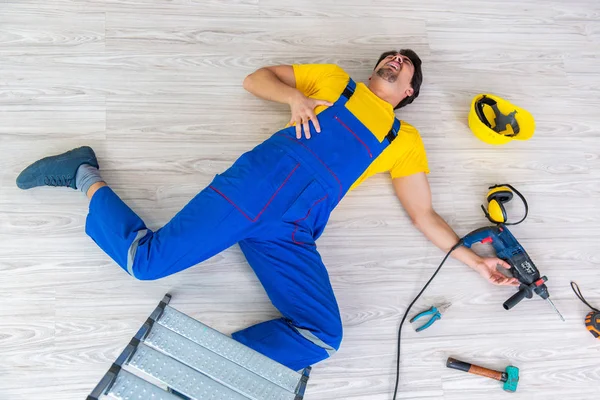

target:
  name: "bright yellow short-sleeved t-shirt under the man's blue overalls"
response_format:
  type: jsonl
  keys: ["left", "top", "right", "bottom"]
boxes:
{"left": 293, "top": 64, "right": 429, "bottom": 190}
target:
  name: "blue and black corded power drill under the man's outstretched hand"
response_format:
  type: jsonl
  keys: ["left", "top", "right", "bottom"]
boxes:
{"left": 462, "top": 224, "right": 565, "bottom": 321}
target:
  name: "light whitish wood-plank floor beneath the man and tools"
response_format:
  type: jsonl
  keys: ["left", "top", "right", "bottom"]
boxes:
{"left": 0, "top": 0, "right": 600, "bottom": 400}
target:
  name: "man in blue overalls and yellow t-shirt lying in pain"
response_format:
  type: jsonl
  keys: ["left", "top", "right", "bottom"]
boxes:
{"left": 17, "top": 50, "right": 516, "bottom": 370}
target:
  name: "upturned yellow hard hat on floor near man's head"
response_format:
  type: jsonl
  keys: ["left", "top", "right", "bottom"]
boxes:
{"left": 469, "top": 94, "right": 535, "bottom": 145}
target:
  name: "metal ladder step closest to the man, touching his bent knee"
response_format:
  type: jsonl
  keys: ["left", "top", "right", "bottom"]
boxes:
{"left": 157, "top": 306, "right": 302, "bottom": 393}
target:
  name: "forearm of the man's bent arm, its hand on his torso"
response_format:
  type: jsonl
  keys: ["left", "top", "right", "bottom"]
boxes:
{"left": 244, "top": 68, "right": 302, "bottom": 104}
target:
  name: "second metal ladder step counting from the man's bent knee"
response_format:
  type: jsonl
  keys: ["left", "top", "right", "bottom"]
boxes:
{"left": 144, "top": 324, "right": 296, "bottom": 400}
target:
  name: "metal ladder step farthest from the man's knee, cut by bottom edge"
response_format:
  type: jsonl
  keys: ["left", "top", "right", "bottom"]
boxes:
{"left": 107, "top": 370, "right": 181, "bottom": 400}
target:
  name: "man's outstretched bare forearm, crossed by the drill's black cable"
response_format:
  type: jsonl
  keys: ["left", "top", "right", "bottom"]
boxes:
{"left": 415, "top": 211, "right": 482, "bottom": 268}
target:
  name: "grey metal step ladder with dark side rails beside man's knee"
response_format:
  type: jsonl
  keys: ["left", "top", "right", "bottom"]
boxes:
{"left": 87, "top": 294, "right": 310, "bottom": 400}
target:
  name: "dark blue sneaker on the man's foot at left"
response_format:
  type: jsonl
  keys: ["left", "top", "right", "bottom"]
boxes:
{"left": 17, "top": 146, "right": 100, "bottom": 189}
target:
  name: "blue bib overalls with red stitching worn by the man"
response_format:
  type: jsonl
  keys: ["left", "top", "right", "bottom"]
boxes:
{"left": 86, "top": 80, "right": 400, "bottom": 370}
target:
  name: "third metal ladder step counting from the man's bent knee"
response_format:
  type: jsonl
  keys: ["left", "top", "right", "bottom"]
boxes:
{"left": 127, "top": 343, "right": 248, "bottom": 400}
